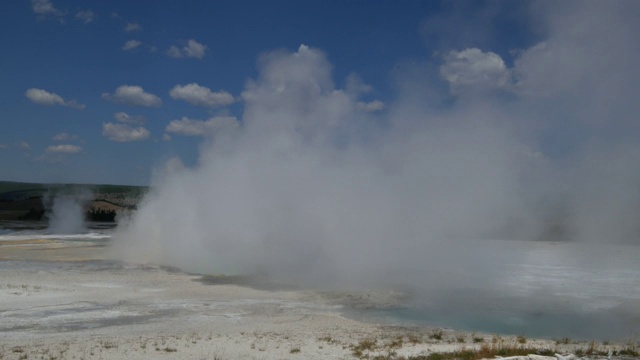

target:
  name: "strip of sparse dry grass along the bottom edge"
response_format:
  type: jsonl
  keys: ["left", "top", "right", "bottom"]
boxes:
{"left": 0, "top": 329, "right": 640, "bottom": 360}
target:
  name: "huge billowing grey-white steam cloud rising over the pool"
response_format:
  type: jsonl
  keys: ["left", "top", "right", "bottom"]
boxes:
{"left": 114, "top": 2, "right": 640, "bottom": 296}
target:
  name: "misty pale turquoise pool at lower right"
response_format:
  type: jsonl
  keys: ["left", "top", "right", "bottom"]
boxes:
{"left": 355, "top": 241, "right": 640, "bottom": 340}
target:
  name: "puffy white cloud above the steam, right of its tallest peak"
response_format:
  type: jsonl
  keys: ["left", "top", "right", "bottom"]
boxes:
{"left": 440, "top": 48, "right": 511, "bottom": 93}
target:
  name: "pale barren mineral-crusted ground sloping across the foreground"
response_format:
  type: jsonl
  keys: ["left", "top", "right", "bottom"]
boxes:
{"left": 0, "top": 240, "right": 635, "bottom": 359}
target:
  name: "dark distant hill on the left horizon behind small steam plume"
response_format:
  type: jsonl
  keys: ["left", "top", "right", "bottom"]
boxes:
{"left": 0, "top": 181, "right": 149, "bottom": 221}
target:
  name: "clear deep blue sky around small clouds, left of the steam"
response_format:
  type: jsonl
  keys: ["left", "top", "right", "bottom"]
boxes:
{"left": 0, "top": 0, "right": 438, "bottom": 184}
